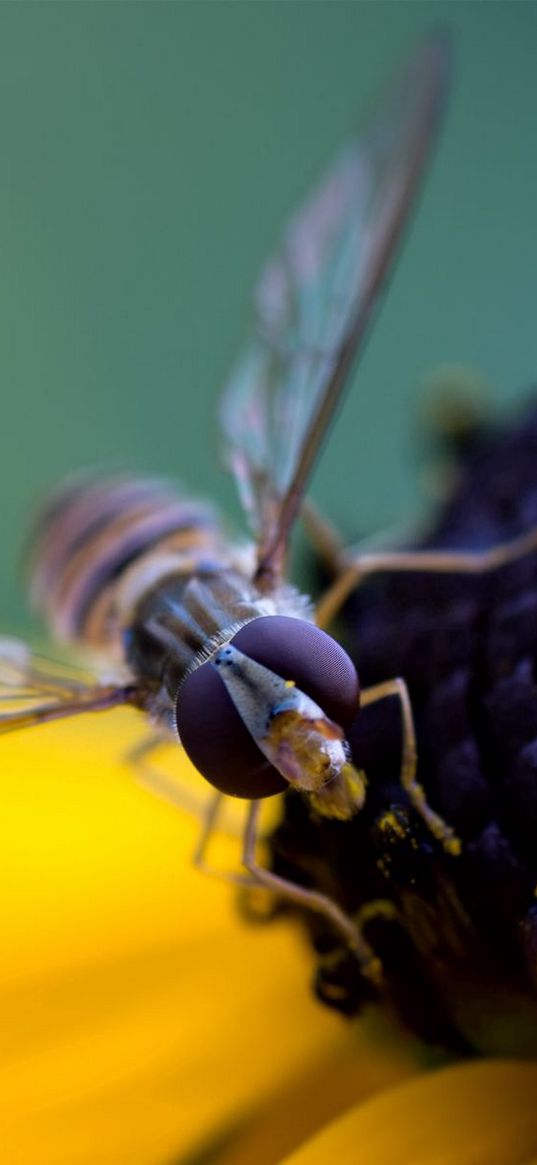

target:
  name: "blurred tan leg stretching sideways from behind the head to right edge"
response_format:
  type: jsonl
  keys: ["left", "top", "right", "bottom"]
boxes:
{"left": 316, "top": 527, "right": 537, "bottom": 627}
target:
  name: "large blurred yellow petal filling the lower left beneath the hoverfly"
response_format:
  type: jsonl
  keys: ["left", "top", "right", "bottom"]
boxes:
{"left": 0, "top": 713, "right": 416, "bottom": 1165}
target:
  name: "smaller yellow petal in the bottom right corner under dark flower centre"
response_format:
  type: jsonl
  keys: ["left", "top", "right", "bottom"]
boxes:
{"left": 284, "top": 1060, "right": 537, "bottom": 1165}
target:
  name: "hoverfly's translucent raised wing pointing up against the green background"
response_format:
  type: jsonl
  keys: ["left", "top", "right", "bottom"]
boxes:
{"left": 221, "top": 37, "right": 448, "bottom": 587}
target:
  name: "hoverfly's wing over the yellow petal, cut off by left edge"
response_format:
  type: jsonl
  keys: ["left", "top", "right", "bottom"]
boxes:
{"left": 0, "top": 636, "right": 134, "bottom": 735}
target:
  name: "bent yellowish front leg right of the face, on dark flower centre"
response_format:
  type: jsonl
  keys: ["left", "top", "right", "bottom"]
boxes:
{"left": 360, "top": 678, "right": 460, "bottom": 855}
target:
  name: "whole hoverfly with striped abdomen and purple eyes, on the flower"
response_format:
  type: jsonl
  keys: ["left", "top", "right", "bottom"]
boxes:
{"left": 5, "top": 37, "right": 526, "bottom": 979}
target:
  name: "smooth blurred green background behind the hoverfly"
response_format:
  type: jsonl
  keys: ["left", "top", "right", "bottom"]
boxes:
{"left": 0, "top": 0, "right": 537, "bottom": 629}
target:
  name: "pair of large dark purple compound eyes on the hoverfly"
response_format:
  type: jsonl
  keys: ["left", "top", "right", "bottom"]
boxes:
{"left": 176, "top": 615, "right": 360, "bottom": 799}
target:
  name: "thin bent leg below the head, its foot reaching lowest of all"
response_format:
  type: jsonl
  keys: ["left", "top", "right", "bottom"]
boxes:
{"left": 242, "top": 800, "right": 382, "bottom": 983}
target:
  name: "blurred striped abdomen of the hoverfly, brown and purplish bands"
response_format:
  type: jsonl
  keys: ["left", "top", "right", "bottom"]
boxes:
{"left": 26, "top": 478, "right": 229, "bottom": 656}
